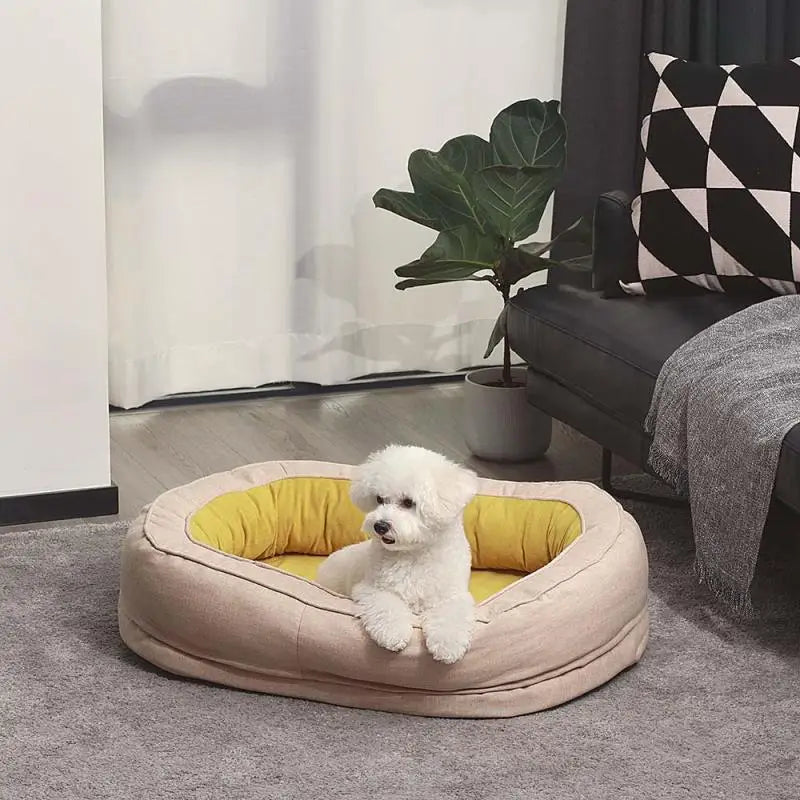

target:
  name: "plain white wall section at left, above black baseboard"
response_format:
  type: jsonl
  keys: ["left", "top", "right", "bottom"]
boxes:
{"left": 0, "top": 0, "right": 110, "bottom": 496}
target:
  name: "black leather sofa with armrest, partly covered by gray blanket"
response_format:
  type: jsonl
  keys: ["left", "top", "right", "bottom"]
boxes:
{"left": 508, "top": 193, "right": 800, "bottom": 513}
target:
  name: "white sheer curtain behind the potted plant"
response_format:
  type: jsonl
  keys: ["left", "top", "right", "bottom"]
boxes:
{"left": 103, "top": 0, "right": 565, "bottom": 408}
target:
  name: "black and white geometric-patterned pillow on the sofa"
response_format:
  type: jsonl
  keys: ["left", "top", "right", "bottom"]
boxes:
{"left": 621, "top": 53, "right": 800, "bottom": 296}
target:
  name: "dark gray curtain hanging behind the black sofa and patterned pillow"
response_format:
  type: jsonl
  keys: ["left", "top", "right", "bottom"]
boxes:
{"left": 554, "top": 0, "right": 800, "bottom": 276}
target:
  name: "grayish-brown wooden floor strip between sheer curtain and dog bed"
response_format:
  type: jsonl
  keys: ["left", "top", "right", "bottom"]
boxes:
{"left": 111, "top": 384, "right": 627, "bottom": 518}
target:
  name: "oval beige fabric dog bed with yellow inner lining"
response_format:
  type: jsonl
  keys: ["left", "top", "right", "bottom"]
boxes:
{"left": 118, "top": 461, "right": 648, "bottom": 717}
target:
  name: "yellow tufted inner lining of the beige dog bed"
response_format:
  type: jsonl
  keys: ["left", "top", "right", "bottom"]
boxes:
{"left": 189, "top": 477, "right": 581, "bottom": 602}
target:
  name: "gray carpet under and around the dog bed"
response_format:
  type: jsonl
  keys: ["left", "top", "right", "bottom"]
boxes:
{"left": 0, "top": 478, "right": 800, "bottom": 800}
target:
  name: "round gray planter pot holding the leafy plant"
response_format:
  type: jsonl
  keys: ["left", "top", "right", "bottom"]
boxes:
{"left": 463, "top": 367, "right": 553, "bottom": 461}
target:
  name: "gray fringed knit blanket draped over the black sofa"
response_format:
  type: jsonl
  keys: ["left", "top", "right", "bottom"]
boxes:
{"left": 645, "top": 295, "right": 800, "bottom": 617}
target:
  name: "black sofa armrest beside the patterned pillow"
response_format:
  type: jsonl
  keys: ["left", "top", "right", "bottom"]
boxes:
{"left": 592, "top": 191, "right": 636, "bottom": 297}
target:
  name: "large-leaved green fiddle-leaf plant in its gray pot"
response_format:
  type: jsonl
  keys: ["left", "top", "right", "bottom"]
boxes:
{"left": 373, "top": 99, "right": 591, "bottom": 461}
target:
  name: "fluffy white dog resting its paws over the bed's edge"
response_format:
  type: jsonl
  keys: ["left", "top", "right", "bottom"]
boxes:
{"left": 317, "top": 445, "right": 477, "bottom": 664}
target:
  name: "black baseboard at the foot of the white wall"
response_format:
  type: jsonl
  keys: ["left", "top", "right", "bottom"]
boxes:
{"left": 0, "top": 483, "right": 119, "bottom": 525}
